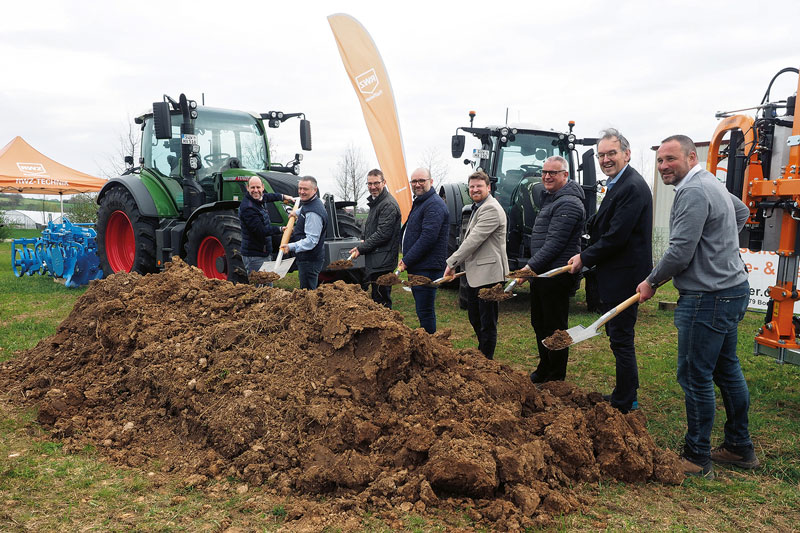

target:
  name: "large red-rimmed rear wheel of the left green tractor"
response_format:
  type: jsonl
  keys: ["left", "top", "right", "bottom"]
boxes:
{"left": 97, "top": 187, "right": 158, "bottom": 276}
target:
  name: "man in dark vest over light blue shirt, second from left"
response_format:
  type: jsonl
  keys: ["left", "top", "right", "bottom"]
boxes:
{"left": 281, "top": 176, "right": 328, "bottom": 290}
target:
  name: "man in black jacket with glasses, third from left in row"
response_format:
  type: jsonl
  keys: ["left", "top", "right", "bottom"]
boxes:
{"left": 350, "top": 168, "right": 401, "bottom": 309}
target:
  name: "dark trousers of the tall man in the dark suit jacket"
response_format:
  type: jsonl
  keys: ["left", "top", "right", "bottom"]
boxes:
{"left": 600, "top": 299, "right": 639, "bottom": 413}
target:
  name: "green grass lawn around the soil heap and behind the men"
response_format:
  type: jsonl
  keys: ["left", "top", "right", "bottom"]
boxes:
{"left": 0, "top": 242, "right": 800, "bottom": 531}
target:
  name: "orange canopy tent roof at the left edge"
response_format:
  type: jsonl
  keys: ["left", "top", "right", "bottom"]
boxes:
{"left": 0, "top": 137, "right": 106, "bottom": 218}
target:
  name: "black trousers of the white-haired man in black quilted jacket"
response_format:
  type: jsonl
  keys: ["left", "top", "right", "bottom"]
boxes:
{"left": 530, "top": 274, "right": 575, "bottom": 381}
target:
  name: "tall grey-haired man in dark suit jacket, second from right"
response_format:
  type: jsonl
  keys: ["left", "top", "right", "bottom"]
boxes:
{"left": 569, "top": 129, "right": 653, "bottom": 413}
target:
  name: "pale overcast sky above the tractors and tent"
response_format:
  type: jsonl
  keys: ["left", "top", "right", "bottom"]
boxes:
{"left": 0, "top": 0, "right": 800, "bottom": 196}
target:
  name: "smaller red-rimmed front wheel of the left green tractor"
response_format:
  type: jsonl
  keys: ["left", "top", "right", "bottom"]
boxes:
{"left": 186, "top": 211, "right": 247, "bottom": 283}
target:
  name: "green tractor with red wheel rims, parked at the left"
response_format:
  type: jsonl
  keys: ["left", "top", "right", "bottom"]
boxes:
{"left": 97, "top": 94, "right": 364, "bottom": 282}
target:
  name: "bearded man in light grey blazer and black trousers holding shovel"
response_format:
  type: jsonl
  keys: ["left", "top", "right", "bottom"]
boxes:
{"left": 444, "top": 170, "right": 508, "bottom": 359}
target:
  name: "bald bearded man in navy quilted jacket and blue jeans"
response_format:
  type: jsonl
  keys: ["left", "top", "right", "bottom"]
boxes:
{"left": 397, "top": 168, "right": 450, "bottom": 333}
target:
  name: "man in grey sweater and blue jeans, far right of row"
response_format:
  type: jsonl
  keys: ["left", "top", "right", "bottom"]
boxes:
{"left": 636, "top": 135, "right": 759, "bottom": 479}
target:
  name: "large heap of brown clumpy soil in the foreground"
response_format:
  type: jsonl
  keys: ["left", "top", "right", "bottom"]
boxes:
{"left": 0, "top": 259, "right": 682, "bottom": 529}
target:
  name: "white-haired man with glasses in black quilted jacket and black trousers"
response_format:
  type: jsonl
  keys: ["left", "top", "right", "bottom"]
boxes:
{"left": 525, "top": 155, "right": 586, "bottom": 383}
